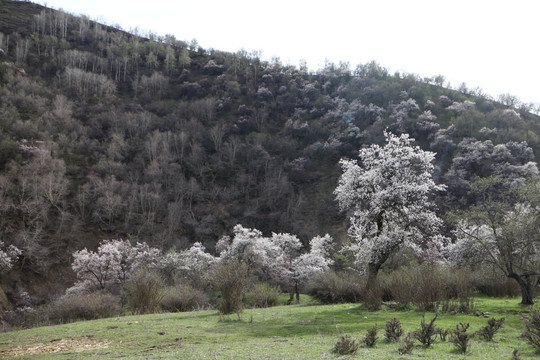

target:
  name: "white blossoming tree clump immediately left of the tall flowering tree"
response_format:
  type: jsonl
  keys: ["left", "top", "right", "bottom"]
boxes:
{"left": 216, "top": 225, "right": 333, "bottom": 300}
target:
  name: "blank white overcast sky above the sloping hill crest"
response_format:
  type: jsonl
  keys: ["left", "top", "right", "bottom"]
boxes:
{"left": 36, "top": 0, "right": 540, "bottom": 104}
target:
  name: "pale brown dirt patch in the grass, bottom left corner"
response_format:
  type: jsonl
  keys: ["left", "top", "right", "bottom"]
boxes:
{"left": 0, "top": 337, "right": 111, "bottom": 358}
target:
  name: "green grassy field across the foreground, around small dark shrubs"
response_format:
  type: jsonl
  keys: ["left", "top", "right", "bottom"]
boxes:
{"left": 0, "top": 298, "right": 539, "bottom": 360}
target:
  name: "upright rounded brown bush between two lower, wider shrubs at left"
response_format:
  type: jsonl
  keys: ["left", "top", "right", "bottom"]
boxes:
{"left": 126, "top": 269, "right": 165, "bottom": 314}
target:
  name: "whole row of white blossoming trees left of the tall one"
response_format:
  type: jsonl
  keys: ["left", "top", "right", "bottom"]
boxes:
{"left": 68, "top": 225, "right": 333, "bottom": 300}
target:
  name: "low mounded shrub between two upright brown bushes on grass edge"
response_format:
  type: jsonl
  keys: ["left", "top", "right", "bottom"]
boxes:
{"left": 159, "top": 284, "right": 210, "bottom": 312}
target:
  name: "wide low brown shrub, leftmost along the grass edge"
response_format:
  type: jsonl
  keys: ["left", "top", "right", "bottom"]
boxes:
{"left": 49, "top": 292, "right": 122, "bottom": 323}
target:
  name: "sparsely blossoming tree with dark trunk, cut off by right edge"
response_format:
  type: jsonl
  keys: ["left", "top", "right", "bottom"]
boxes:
{"left": 448, "top": 178, "right": 540, "bottom": 305}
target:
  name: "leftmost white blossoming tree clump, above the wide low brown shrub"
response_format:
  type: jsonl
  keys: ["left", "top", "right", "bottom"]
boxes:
{"left": 68, "top": 239, "right": 161, "bottom": 292}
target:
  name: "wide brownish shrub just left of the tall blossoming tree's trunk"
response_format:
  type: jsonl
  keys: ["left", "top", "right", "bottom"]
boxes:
{"left": 306, "top": 271, "right": 365, "bottom": 304}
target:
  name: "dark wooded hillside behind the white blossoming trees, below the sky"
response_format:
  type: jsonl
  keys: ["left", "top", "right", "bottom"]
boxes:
{"left": 0, "top": 0, "right": 540, "bottom": 307}
